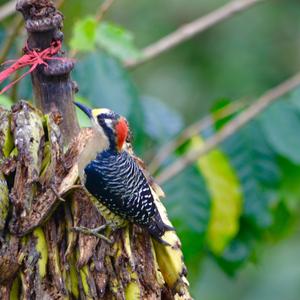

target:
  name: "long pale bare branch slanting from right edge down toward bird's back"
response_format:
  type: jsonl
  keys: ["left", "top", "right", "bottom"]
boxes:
{"left": 157, "top": 73, "right": 300, "bottom": 184}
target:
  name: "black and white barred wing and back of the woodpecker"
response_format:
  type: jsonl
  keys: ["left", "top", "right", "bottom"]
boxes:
{"left": 85, "top": 152, "right": 158, "bottom": 226}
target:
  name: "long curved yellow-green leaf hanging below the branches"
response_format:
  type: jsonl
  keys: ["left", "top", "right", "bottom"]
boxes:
{"left": 191, "top": 137, "right": 243, "bottom": 254}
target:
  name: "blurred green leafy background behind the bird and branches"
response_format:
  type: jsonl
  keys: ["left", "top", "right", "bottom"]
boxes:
{"left": 0, "top": 0, "right": 300, "bottom": 300}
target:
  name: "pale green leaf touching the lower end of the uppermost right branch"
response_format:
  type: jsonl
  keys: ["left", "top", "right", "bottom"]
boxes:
{"left": 96, "top": 22, "right": 141, "bottom": 60}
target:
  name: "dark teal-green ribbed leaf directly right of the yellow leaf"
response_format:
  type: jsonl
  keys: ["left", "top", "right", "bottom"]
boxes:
{"left": 221, "top": 122, "right": 281, "bottom": 228}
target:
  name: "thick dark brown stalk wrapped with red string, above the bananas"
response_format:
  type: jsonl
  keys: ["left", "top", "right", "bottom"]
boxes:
{"left": 17, "top": 0, "right": 79, "bottom": 144}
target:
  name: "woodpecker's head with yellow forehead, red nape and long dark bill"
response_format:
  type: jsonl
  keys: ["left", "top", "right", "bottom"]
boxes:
{"left": 74, "top": 102, "right": 129, "bottom": 152}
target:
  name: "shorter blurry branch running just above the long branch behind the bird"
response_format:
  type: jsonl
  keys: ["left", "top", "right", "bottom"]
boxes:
{"left": 148, "top": 102, "right": 245, "bottom": 174}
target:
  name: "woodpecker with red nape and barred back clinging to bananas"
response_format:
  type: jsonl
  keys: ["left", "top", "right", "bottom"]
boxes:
{"left": 74, "top": 102, "right": 175, "bottom": 246}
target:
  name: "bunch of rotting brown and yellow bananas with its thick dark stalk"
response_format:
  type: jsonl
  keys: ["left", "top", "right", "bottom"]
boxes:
{"left": 0, "top": 0, "right": 190, "bottom": 299}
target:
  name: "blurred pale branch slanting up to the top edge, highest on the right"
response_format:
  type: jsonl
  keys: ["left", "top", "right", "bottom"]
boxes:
{"left": 124, "top": 0, "right": 265, "bottom": 68}
